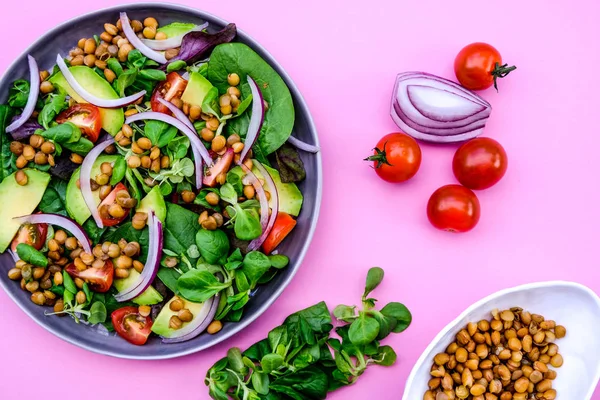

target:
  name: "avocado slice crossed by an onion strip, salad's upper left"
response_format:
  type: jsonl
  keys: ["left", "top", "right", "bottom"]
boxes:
{"left": 50, "top": 65, "right": 125, "bottom": 136}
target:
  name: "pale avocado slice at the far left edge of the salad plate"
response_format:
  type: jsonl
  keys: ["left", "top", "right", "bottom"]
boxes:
{"left": 0, "top": 169, "right": 50, "bottom": 253}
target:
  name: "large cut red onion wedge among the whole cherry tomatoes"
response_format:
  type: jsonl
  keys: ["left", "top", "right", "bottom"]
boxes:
{"left": 391, "top": 72, "right": 492, "bottom": 143}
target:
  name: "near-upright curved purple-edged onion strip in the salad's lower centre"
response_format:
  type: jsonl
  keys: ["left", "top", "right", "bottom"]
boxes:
{"left": 115, "top": 211, "right": 163, "bottom": 302}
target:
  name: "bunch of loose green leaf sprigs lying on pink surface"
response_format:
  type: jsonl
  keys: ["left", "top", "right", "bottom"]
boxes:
{"left": 205, "top": 267, "right": 412, "bottom": 400}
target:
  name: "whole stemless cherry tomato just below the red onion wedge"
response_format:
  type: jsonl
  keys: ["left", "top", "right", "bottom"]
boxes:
{"left": 452, "top": 138, "right": 508, "bottom": 190}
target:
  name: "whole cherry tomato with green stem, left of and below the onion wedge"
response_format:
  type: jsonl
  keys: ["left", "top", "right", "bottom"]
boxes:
{"left": 365, "top": 132, "right": 421, "bottom": 182}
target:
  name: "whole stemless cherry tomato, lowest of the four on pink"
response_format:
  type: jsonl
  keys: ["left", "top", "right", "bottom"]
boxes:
{"left": 427, "top": 185, "right": 481, "bottom": 232}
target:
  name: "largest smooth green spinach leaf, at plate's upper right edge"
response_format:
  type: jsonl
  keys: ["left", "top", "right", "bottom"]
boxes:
{"left": 208, "top": 43, "right": 294, "bottom": 155}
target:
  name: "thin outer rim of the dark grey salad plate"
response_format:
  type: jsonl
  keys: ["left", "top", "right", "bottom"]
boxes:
{"left": 0, "top": 2, "right": 323, "bottom": 360}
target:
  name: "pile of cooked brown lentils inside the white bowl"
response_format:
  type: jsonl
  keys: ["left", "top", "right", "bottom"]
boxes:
{"left": 423, "top": 307, "right": 567, "bottom": 400}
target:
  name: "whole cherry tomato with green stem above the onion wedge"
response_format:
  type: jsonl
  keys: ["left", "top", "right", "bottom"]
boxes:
{"left": 454, "top": 43, "right": 517, "bottom": 90}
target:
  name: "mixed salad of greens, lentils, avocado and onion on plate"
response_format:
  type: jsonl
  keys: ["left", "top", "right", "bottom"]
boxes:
{"left": 0, "top": 13, "right": 318, "bottom": 345}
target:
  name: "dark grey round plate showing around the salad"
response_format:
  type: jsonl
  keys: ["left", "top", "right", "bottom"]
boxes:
{"left": 0, "top": 3, "right": 322, "bottom": 359}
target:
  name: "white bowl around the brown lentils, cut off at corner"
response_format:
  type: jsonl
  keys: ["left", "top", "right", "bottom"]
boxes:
{"left": 402, "top": 281, "right": 600, "bottom": 400}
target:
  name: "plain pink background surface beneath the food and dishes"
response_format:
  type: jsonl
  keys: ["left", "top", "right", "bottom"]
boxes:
{"left": 0, "top": 0, "right": 600, "bottom": 400}
